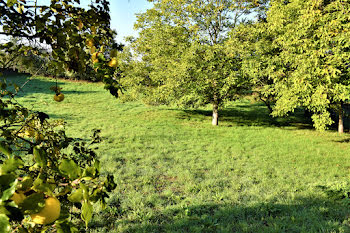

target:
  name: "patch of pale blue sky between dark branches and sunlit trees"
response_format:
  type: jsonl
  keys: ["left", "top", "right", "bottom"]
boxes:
{"left": 109, "top": 0, "right": 152, "bottom": 42}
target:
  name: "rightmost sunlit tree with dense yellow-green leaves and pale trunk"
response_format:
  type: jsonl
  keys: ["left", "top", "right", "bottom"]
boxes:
{"left": 230, "top": 0, "right": 350, "bottom": 133}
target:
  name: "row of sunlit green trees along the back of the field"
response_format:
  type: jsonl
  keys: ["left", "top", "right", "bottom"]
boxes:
{"left": 121, "top": 0, "right": 350, "bottom": 132}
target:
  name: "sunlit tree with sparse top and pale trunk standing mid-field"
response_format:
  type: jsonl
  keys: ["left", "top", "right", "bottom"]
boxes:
{"left": 126, "top": 0, "right": 262, "bottom": 125}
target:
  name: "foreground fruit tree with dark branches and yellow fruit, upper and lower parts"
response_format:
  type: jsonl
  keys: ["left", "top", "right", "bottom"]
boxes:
{"left": 0, "top": 0, "right": 119, "bottom": 232}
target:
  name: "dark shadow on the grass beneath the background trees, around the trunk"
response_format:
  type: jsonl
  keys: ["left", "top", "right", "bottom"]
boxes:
{"left": 178, "top": 103, "right": 313, "bottom": 129}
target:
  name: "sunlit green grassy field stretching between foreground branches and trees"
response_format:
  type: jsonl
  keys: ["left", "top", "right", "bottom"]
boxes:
{"left": 5, "top": 76, "right": 350, "bottom": 232}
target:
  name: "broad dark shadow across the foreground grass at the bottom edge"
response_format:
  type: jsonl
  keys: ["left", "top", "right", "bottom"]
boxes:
{"left": 101, "top": 199, "right": 350, "bottom": 232}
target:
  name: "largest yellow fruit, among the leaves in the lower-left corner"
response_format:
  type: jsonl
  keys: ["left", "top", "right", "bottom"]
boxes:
{"left": 30, "top": 197, "right": 61, "bottom": 225}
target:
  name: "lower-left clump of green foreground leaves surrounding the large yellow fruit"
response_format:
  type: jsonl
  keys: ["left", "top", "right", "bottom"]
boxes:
{"left": 0, "top": 81, "right": 115, "bottom": 232}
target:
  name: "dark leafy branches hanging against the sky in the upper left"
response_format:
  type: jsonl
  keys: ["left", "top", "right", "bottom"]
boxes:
{"left": 0, "top": 0, "right": 120, "bottom": 93}
